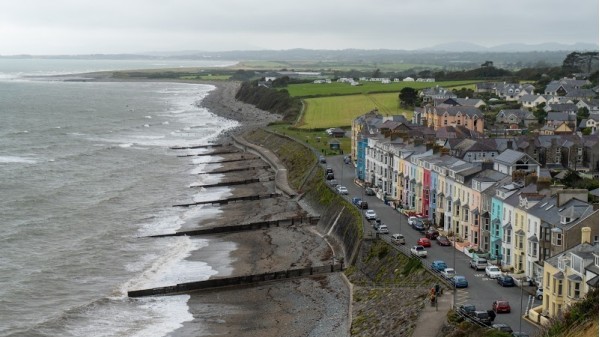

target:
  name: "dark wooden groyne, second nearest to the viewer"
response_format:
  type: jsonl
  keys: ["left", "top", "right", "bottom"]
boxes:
{"left": 150, "top": 216, "right": 320, "bottom": 238}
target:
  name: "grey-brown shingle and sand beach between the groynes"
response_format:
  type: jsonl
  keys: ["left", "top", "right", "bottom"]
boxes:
{"left": 168, "top": 82, "right": 351, "bottom": 337}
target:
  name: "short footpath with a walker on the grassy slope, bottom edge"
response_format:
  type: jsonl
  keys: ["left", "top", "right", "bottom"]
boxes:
{"left": 412, "top": 292, "right": 452, "bottom": 337}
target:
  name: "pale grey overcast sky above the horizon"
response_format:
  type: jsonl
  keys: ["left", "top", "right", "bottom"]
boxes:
{"left": 0, "top": 0, "right": 599, "bottom": 55}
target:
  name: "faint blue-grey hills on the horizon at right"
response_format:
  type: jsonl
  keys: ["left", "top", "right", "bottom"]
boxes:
{"left": 419, "top": 41, "right": 598, "bottom": 53}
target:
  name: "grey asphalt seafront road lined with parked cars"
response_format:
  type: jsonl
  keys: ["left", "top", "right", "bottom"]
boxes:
{"left": 322, "top": 156, "right": 541, "bottom": 334}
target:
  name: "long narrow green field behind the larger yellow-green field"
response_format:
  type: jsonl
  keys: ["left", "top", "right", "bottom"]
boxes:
{"left": 286, "top": 81, "right": 479, "bottom": 97}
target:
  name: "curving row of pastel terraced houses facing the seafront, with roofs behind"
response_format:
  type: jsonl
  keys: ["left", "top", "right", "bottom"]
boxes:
{"left": 351, "top": 110, "right": 599, "bottom": 320}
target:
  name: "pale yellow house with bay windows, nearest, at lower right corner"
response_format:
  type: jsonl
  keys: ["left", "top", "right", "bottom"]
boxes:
{"left": 528, "top": 227, "right": 599, "bottom": 324}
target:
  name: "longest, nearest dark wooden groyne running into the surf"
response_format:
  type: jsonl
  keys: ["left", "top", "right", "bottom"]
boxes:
{"left": 127, "top": 263, "right": 344, "bottom": 297}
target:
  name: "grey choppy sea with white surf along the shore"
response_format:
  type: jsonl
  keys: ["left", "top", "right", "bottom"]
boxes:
{"left": 0, "top": 58, "right": 243, "bottom": 337}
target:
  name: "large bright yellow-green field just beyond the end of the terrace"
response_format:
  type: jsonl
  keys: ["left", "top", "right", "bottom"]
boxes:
{"left": 296, "top": 93, "right": 413, "bottom": 129}
